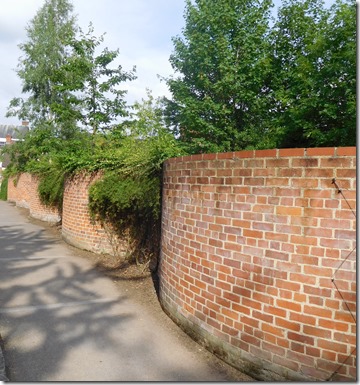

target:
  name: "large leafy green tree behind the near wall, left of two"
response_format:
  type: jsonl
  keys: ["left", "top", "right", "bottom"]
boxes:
{"left": 163, "top": 0, "right": 272, "bottom": 152}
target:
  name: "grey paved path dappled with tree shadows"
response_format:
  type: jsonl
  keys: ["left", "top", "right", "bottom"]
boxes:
{"left": 0, "top": 201, "right": 251, "bottom": 382}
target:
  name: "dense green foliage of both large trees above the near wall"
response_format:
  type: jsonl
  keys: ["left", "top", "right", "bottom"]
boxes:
{"left": 166, "top": 0, "right": 356, "bottom": 153}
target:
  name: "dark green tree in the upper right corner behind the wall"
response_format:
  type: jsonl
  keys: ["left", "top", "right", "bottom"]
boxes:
{"left": 269, "top": 0, "right": 356, "bottom": 147}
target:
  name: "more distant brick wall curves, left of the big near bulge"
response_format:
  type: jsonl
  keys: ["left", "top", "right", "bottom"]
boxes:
{"left": 8, "top": 173, "right": 127, "bottom": 256}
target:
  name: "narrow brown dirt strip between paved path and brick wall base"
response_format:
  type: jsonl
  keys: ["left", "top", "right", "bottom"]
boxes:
{"left": 20, "top": 209, "right": 256, "bottom": 382}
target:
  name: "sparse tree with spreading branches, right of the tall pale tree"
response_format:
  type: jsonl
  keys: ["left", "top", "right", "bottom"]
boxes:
{"left": 51, "top": 25, "right": 136, "bottom": 134}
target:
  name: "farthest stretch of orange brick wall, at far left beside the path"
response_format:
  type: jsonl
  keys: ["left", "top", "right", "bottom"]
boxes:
{"left": 8, "top": 173, "right": 61, "bottom": 223}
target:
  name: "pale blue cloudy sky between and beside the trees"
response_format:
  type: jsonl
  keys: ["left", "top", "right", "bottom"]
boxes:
{"left": 0, "top": 0, "right": 185, "bottom": 125}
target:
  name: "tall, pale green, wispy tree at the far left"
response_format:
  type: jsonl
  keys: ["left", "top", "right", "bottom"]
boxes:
{"left": 7, "top": 0, "right": 77, "bottom": 127}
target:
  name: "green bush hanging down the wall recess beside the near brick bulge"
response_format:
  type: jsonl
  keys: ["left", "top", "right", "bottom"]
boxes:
{"left": 89, "top": 172, "right": 161, "bottom": 262}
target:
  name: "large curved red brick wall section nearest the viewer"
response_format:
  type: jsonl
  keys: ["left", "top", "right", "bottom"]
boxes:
{"left": 159, "top": 147, "right": 356, "bottom": 380}
